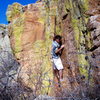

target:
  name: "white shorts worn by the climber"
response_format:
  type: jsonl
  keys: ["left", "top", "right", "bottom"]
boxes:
{"left": 53, "top": 57, "right": 64, "bottom": 70}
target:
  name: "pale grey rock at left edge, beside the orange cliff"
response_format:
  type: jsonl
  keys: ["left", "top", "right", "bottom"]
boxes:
{"left": 0, "top": 25, "right": 18, "bottom": 89}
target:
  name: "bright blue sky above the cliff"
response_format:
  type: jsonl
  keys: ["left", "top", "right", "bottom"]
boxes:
{"left": 0, "top": 0, "right": 37, "bottom": 24}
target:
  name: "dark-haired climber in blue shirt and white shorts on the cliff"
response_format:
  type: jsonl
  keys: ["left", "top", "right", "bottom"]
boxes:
{"left": 51, "top": 35, "right": 64, "bottom": 82}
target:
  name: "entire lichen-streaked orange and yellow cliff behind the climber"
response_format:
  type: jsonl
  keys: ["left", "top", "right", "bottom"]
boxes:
{"left": 0, "top": 0, "right": 100, "bottom": 98}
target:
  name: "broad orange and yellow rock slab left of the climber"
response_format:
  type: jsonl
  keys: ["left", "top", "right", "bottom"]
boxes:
{"left": 7, "top": 2, "right": 53, "bottom": 94}
